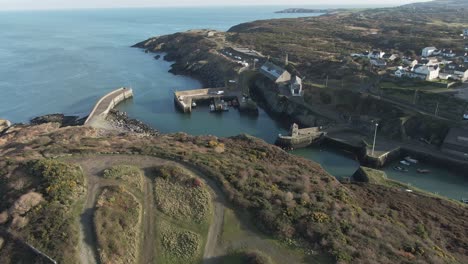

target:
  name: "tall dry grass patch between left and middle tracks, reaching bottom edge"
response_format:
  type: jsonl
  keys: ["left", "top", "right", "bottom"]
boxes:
{"left": 94, "top": 187, "right": 141, "bottom": 264}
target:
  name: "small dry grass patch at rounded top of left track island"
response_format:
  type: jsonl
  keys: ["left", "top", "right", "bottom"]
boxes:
{"left": 103, "top": 165, "right": 143, "bottom": 190}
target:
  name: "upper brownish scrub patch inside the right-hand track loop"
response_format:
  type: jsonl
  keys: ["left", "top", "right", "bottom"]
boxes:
{"left": 155, "top": 166, "right": 211, "bottom": 224}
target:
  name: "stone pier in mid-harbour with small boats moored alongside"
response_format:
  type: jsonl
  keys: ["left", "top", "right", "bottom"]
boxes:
{"left": 174, "top": 88, "right": 258, "bottom": 113}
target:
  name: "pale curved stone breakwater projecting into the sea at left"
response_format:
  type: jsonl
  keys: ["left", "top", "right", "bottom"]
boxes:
{"left": 84, "top": 87, "right": 133, "bottom": 127}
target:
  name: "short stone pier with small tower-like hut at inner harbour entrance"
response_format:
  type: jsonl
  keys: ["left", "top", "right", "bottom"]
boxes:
{"left": 275, "top": 123, "right": 326, "bottom": 149}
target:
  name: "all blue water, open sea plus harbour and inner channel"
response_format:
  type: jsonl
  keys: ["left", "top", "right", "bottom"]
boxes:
{"left": 0, "top": 7, "right": 468, "bottom": 199}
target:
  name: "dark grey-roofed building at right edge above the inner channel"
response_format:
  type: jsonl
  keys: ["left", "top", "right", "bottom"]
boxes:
{"left": 441, "top": 128, "right": 468, "bottom": 159}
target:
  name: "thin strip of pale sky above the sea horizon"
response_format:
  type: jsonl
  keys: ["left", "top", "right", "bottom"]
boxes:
{"left": 0, "top": 0, "right": 423, "bottom": 10}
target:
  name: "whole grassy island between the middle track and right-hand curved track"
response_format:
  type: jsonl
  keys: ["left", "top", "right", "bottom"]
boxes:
{"left": 154, "top": 166, "right": 212, "bottom": 264}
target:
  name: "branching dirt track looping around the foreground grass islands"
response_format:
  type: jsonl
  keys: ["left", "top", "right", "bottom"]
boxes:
{"left": 67, "top": 155, "right": 226, "bottom": 264}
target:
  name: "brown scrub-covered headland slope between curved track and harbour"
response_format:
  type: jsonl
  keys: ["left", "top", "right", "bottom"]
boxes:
{"left": 0, "top": 124, "right": 468, "bottom": 263}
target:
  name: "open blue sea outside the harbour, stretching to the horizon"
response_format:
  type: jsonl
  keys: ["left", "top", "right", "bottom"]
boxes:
{"left": 0, "top": 7, "right": 314, "bottom": 123}
